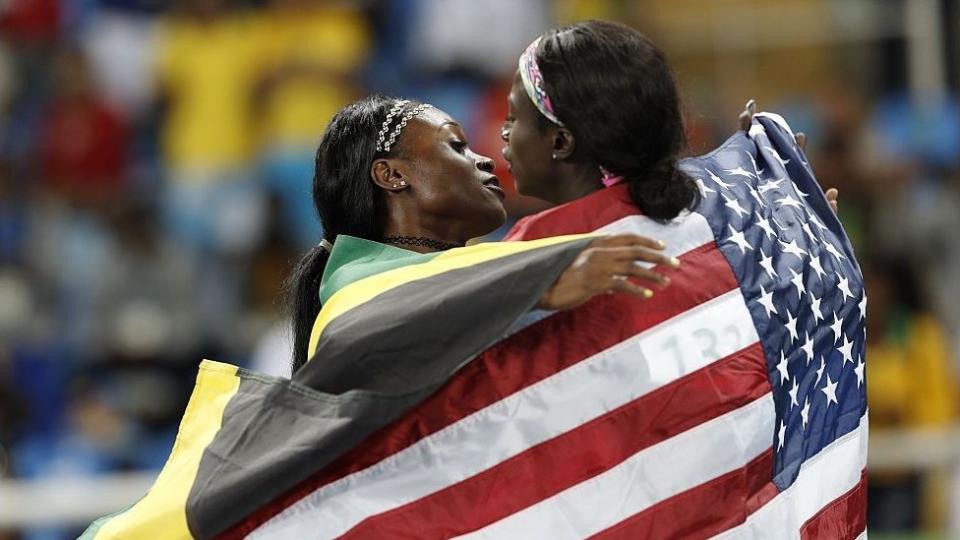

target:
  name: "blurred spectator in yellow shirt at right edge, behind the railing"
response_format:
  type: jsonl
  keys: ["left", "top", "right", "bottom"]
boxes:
{"left": 864, "top": 262, "right": 958, "bottom": 530}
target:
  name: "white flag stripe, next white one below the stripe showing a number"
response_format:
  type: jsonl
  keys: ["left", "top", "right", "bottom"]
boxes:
{"left": 458, "top": 393, "right": 776, "bottom": 540}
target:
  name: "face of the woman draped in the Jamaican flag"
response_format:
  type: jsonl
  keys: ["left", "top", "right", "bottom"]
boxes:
{"left": 396, "top": 107, "right": 507, "bottom": 239}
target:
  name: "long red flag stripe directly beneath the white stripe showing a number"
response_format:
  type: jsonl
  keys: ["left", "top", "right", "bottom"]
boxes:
{"left": 341, "top": 342, "right": 772, "bottom": 539}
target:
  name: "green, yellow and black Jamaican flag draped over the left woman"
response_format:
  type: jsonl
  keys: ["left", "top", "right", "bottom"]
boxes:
{"left": 82, "top": 235, "right": 591, "bottom": 540}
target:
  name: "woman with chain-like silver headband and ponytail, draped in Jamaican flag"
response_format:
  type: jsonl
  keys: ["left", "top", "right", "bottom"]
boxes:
{"left": 287, "top": 96, "right": 675, "bottom": 371}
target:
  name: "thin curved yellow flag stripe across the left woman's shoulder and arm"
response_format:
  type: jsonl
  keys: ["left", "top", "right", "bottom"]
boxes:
{"left": 307, "top": 234, "right": 593, "bottom": 359}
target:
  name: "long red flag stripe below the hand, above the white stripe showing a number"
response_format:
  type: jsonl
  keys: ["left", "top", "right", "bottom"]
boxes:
{"left": 221, "top": 242, "right": 737, "bottom": 538}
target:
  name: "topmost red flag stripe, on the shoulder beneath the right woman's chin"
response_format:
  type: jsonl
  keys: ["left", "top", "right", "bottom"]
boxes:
{"left": 505, "top": 184, "right": 642, "bottom": 240}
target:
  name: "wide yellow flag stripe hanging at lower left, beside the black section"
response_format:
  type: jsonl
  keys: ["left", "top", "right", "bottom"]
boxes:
{"left": 94, "top": 360, "right": 240, "bottom": 540}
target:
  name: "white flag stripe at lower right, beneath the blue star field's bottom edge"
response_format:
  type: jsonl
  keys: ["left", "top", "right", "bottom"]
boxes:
{"left": 714, "top": 413, "right": 868, "bottom": 540}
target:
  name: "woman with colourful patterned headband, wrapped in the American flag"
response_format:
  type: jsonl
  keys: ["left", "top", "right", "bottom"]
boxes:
{"left": 501, "top": 21, "right": 836, "bottom": 230}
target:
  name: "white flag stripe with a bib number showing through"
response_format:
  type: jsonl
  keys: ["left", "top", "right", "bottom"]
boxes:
{"left": 251, "top": 289, "right": 760, "bottom": 538}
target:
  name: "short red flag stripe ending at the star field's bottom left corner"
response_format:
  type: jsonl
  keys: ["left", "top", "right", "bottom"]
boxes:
{"left": 591, "top": 448, "right": 779, "bottom": 540}
